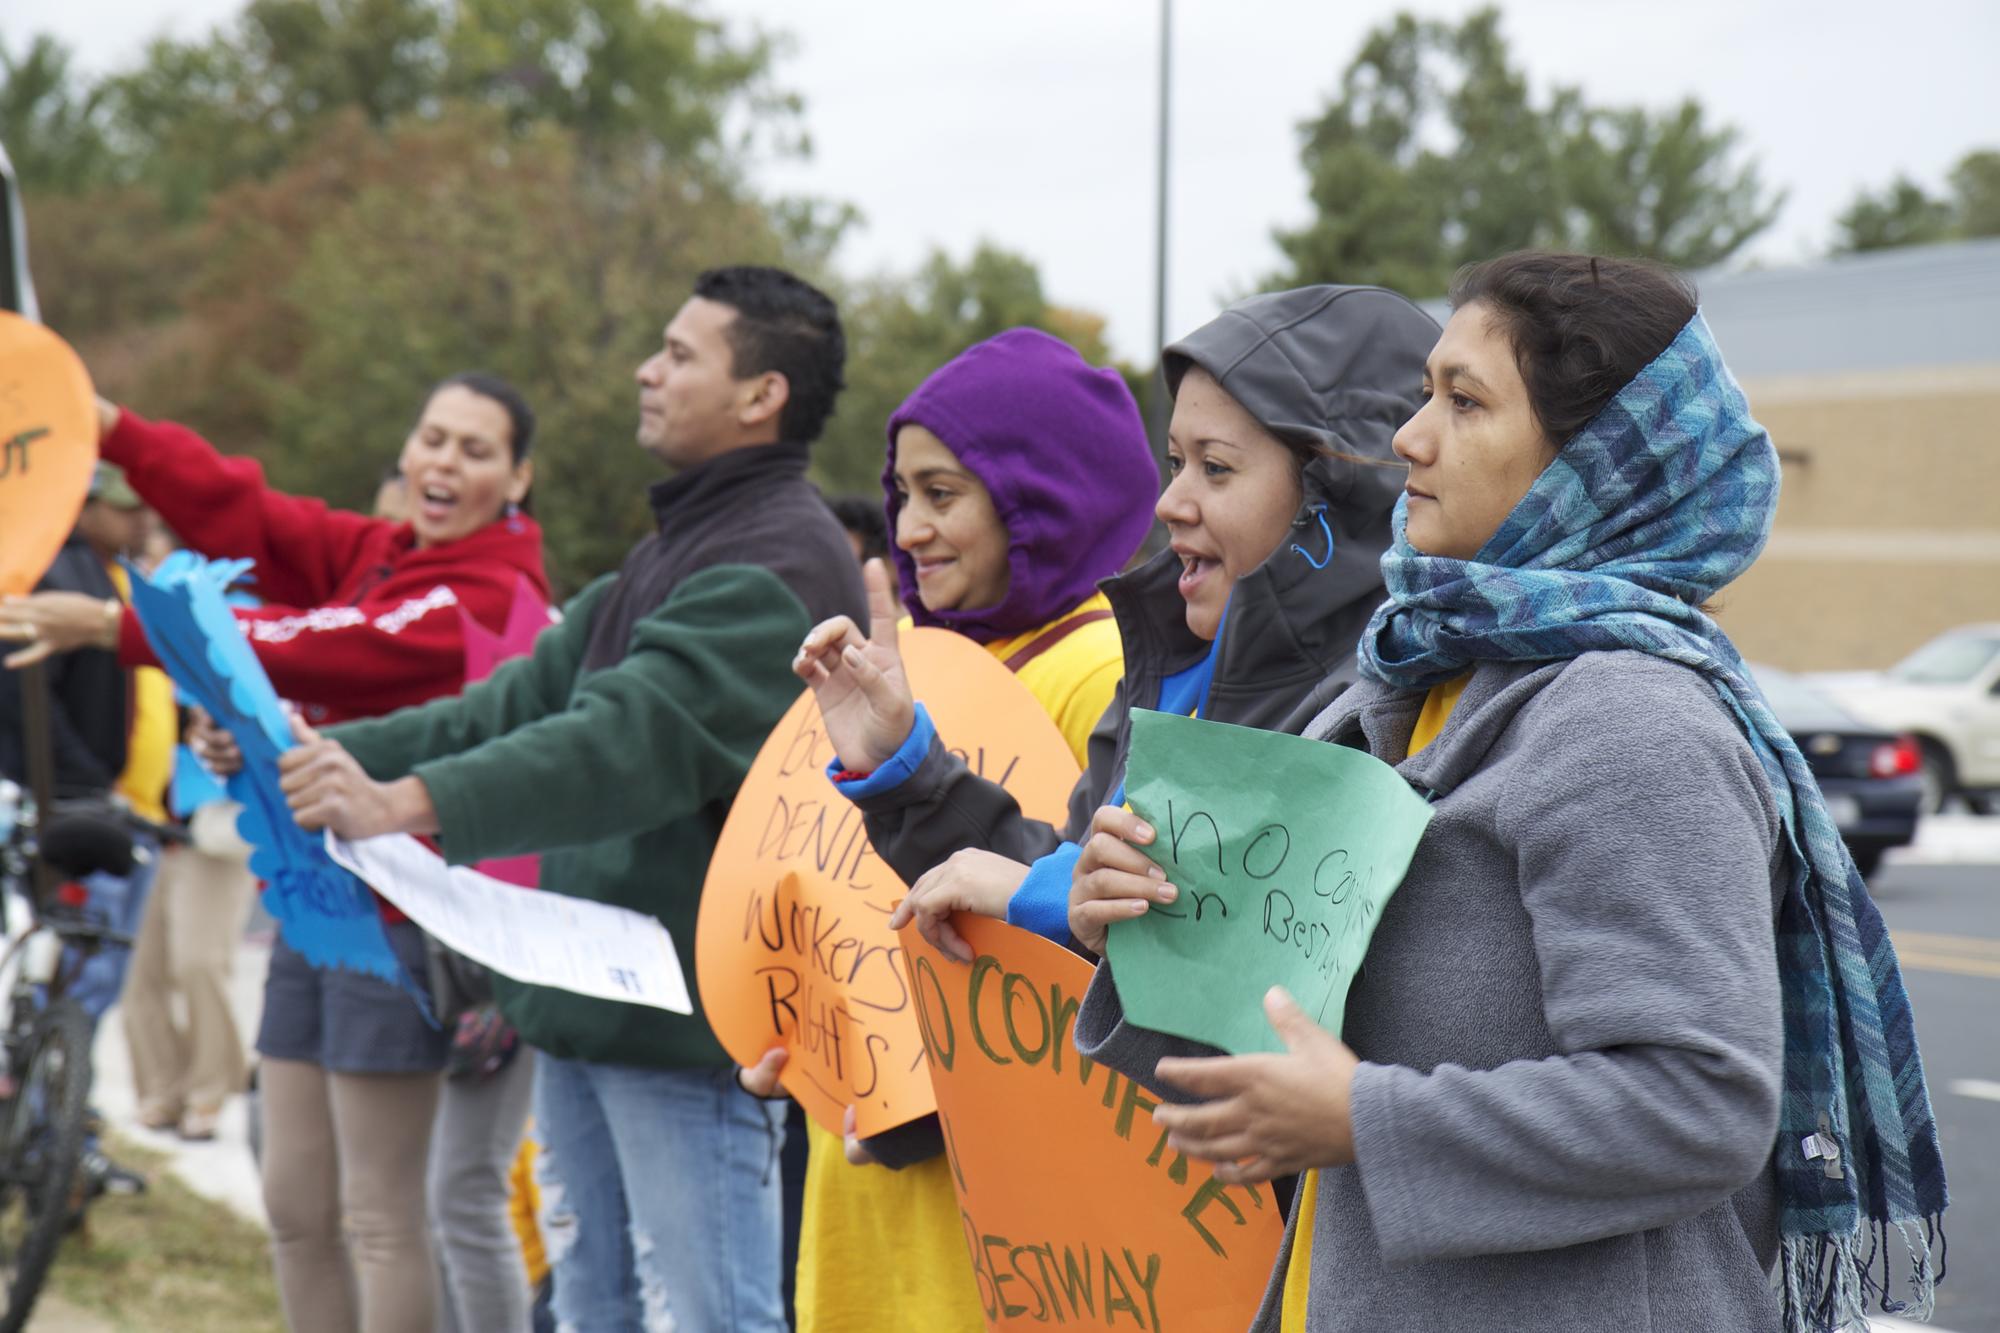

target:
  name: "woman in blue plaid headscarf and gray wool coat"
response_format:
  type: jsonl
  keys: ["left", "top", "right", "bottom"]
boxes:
{"left": 1072, "top": 254, "right": 1946, "bottom": 1333}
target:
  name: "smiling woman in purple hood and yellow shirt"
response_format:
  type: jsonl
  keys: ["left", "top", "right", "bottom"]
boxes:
{"left": 744, "top": 328, "right": 1158, "bottom": 1333}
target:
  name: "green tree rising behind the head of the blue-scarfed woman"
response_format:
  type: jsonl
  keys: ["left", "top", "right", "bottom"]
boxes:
{"left": 1272, "top": 8, "right": 1782, "bottom": 296}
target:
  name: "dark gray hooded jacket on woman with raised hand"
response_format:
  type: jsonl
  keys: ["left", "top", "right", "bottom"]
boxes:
{"left": 860, "top": 286, "right": 1438, "bottom": 883}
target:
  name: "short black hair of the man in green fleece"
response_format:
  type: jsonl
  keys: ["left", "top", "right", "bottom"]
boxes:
{"left": 694, "top": 264, "right": 848, "bottom": 444}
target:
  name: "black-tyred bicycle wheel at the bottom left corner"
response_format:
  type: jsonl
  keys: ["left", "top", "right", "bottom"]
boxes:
{"left": 0, "top": 1001, "right": 90, "bottom": 1333}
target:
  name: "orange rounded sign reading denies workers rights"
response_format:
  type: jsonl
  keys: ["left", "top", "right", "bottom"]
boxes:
{"left": 694, "top": 628, "right": 1078, "bottom": 1137}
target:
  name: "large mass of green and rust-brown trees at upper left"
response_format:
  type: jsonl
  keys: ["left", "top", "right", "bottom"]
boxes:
{"left": 0, "top": 0, "right": 1108, "bottom": 588}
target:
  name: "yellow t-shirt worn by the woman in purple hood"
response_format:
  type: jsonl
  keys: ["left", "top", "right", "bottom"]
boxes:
{"left": 796, "top": 592, "right": 1124, "bottom": 1333}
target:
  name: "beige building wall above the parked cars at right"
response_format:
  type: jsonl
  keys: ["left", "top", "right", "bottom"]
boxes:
{"left": 1716, "top": 366, "right": 2000, "bottom": 671}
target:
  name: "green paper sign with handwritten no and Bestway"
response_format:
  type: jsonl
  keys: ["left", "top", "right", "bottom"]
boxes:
{"left": 1106, "top": 711, "right": 1430, "bottom": 1055}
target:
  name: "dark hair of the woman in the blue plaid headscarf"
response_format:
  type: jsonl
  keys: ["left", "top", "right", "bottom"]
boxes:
{"left": 1450, "top": 250, "right": 1696, "bottom": 448}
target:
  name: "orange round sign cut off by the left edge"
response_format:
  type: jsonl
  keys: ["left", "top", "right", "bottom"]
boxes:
{"left": 0, "top": 310, "right": 98, "bottom": 596}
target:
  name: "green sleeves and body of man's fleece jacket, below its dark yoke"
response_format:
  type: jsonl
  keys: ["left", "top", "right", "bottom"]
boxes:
{"left": 328, "top": 564, "right": 810, "bottom": 1069}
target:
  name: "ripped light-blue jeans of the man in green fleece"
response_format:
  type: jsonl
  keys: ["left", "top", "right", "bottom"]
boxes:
{"left": 534, "top": 1055, "right": 786, "bottom": 1333}
